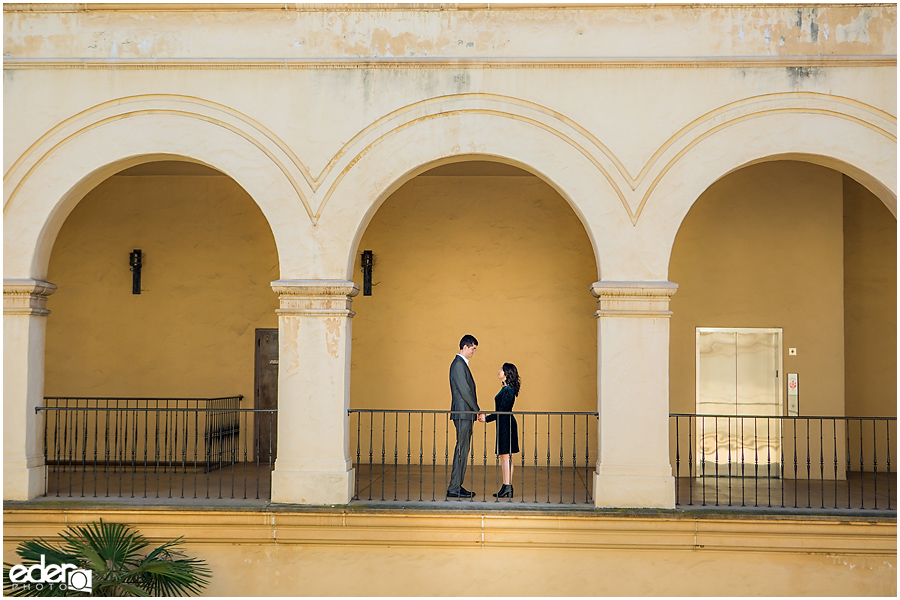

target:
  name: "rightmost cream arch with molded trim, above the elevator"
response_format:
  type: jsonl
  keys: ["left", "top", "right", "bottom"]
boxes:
{"left": 635, "top": 103, "right": 897, "bottom": 276}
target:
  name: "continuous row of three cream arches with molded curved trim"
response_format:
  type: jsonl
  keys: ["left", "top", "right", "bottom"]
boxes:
{"left": 4, "top": 78, "right": 896, "bottom": 280}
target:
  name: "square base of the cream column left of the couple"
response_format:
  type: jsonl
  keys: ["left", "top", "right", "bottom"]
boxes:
{"left": 272, "top": 469, "right": 356, "bottom": 505}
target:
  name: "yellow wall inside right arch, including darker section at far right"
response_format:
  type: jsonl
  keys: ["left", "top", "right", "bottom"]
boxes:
{"left": 670, "top": 161, "right": 897, "bottom": 478}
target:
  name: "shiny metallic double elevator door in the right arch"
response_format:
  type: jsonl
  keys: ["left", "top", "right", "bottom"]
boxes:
{"left": 696, "top": 327, "right": 782, "bottom": 477}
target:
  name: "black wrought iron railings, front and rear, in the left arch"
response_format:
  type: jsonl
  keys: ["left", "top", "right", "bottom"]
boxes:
{"left": 37, "top": 396, "right": 277, "bottom": 499}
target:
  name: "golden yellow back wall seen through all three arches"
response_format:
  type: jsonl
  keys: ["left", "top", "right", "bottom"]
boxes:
{"left": 37, "top": 162, "right": 896, "bottom": 476}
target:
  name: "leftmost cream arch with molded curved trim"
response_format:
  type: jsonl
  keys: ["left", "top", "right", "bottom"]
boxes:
{"left": 4, "top": 101, "right": 311, "bottom": 279}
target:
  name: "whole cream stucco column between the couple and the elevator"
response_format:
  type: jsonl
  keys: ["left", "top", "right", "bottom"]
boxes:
{"left": 591, "top": 281, "right": 678, "bottom": 508}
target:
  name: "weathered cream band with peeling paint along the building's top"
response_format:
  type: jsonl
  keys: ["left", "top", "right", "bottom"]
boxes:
{"left": 4, "top": 5, "right": 896, "bottom": 59}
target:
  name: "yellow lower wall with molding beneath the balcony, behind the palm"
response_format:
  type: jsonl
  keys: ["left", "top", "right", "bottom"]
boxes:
{"left": 3, "top": 507, "right": 897, "bottom": 597}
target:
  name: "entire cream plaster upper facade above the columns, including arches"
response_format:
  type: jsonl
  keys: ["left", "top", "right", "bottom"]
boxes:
{"left": 3, "top": 5, "right": 896, "bottom": 280}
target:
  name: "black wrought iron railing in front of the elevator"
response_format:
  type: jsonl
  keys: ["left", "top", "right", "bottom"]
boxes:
{"left": 669, "top": 414, "right": 897, "bottom": 511}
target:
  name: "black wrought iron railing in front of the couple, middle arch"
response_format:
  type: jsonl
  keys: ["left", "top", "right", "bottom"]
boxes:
{"left": 349, "top": 409, "right": 597, "bottom": 505}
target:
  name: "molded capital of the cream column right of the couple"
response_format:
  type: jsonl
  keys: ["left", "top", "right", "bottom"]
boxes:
{"left": 591, "top": 281, "right": 678, "bottom": 318}
